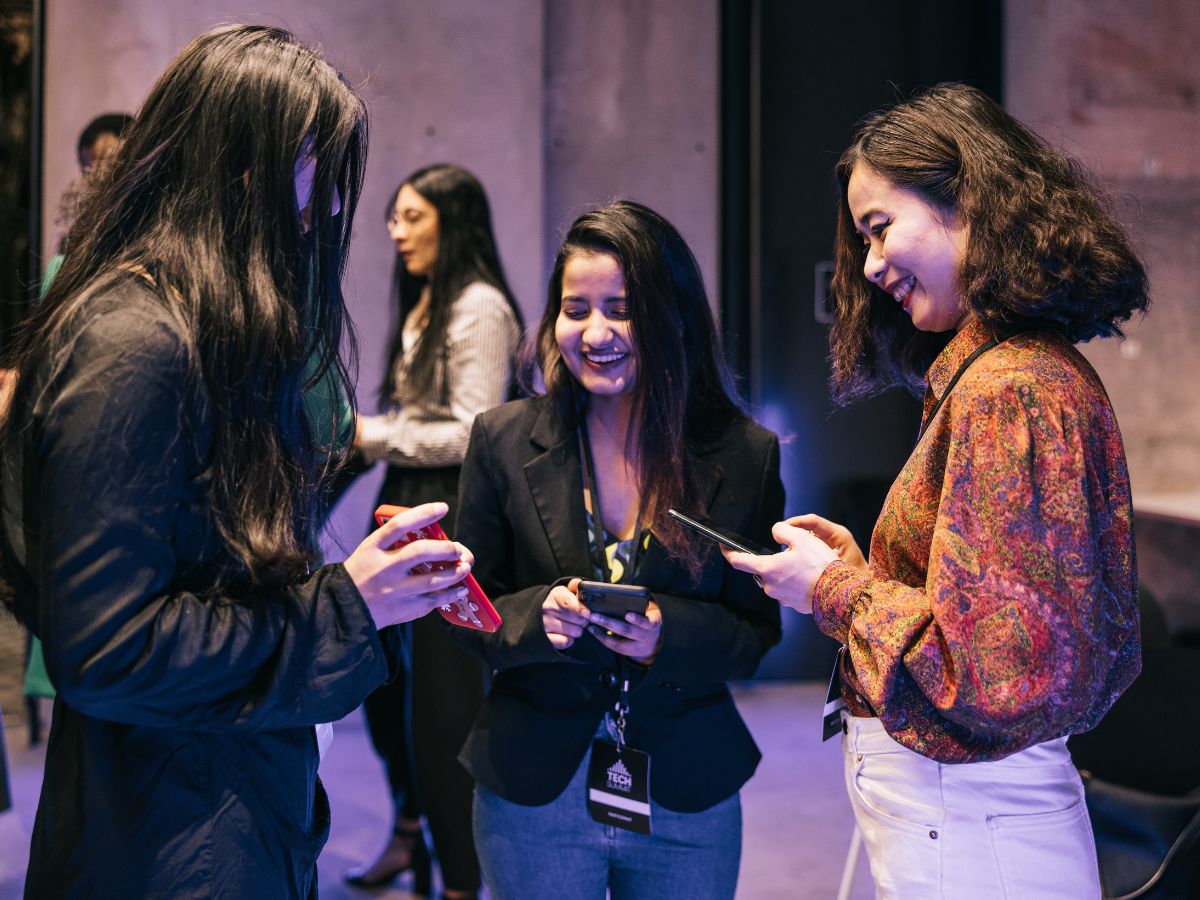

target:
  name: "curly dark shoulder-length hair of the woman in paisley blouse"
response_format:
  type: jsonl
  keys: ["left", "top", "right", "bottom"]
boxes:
{"left": 830, "top": 83, "right": 1150, "bottom": 403}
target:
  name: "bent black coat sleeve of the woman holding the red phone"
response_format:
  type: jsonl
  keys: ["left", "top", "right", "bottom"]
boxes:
{"left": 24, "top": 304, "right": 388, "bottom": 731}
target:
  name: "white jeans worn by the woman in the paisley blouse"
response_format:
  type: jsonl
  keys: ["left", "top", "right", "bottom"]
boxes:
{"left": 842, "top": 714, "right": 1100, "bottom": 900}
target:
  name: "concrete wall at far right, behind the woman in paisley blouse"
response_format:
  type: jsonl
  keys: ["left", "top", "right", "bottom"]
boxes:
{"left": 1006, "top": 0, "right": 1200, "bottom": 494}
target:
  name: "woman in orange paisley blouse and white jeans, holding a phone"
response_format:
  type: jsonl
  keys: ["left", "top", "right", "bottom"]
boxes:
{"left": 726, "top": 84, "right": 1148, "bottom": 898}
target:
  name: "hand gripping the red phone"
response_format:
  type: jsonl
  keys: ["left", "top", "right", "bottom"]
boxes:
{"left": 344, "top": 503, "right": 475, "bottom": 628}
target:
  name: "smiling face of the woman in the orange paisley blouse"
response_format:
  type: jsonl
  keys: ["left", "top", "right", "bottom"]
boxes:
{"left": 846, "top": 163, "right": 967, "bottom": 331}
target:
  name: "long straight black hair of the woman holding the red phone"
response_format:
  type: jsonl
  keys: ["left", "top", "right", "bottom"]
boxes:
{"left": 5, "top": 25, "right": 366, "bottom": 584}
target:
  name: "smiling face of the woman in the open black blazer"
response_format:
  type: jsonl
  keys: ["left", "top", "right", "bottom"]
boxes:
{"left": 554, "top": 252, "right": 637, "bottom": 398}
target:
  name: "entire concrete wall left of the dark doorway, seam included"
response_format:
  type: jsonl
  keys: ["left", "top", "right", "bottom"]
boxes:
{"left": 43, "top": 0, "right": 718, "bottom": 557}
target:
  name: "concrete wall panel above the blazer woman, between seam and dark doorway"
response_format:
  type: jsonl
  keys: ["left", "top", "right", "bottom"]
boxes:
{"left": 545, "top": 0, "right": 720, "bottom": 301}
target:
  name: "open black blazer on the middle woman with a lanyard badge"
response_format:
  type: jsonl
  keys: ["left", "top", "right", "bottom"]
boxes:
{"left": 455, "top": 397, "right": 784, "bottom": 812}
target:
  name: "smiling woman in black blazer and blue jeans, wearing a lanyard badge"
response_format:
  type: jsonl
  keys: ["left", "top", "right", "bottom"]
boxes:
{"left": 456, "top": 202, "right": 784, "bottom": 900}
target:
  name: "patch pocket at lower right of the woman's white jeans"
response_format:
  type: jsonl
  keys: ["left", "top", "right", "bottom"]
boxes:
{"left": 988, "top": 800, "right": 1100, "bottom": 900}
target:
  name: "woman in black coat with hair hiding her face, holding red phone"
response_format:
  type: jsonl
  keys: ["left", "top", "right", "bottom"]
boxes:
{"left": 0, "top": 25, "right": 469, "bottom": 898}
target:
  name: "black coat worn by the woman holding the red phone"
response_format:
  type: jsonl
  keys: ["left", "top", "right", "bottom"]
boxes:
{"left": 2, "top": 278, "right": 400, "bottom": 899}
